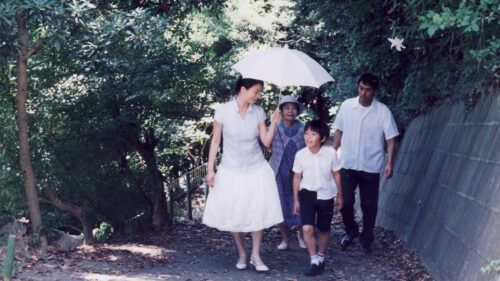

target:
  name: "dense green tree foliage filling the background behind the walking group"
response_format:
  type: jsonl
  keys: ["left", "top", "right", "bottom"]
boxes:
{"left": 0, "top": 0, "right": 500, "bottom": 236}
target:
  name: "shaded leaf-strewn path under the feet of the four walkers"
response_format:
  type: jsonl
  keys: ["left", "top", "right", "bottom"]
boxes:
{"left": 6, "top": 214, "right": 433, "bottom": 281}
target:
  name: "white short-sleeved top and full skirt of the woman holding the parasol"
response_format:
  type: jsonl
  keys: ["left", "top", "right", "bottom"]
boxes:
{"left": 203, "top": 99, "right": 283, "bottom": 232}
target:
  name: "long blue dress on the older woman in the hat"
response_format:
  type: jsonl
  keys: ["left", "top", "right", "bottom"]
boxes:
{"left": 276, "top": 122, "right": 303, "bottom": 226}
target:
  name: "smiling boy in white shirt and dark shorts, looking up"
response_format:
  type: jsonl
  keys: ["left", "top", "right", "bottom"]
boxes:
{"left": 293, "top": 120, "right": 342, "bottom": 276}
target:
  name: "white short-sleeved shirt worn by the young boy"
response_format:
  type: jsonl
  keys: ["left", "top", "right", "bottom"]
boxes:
{"left": 292, "top": 145, "right": 342, "bottom": 200}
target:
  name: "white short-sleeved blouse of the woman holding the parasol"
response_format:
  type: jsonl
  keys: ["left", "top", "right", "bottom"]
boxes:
{"left": 214, "top": 99, "right": 266, "bottom": 172}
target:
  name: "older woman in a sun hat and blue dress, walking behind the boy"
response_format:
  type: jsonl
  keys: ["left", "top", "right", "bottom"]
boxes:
{"left": 269, "top": 95, "right": 306, "bottom": 250}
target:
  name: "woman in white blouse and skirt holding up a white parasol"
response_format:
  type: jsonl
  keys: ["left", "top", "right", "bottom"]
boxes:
{"left": 203, "top": 75, "right": 283, "bottom": 271}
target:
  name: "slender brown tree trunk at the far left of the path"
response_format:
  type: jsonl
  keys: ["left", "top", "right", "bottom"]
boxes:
{"left": 16, "top": 11, "right": 47, "bottom": 252}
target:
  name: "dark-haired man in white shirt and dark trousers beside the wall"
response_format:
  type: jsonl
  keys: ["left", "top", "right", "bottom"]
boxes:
{"left": 333, "top": 73, "right": 399, "bottom": 253}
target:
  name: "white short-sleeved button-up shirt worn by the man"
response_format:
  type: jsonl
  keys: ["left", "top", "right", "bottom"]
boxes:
{"left": 335, "top": 97, "right": 399, "bottom": 173}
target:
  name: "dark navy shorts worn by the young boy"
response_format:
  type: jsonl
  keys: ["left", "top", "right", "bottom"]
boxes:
{"left": 299, "top": 189, "right": 333, "bottom": 232}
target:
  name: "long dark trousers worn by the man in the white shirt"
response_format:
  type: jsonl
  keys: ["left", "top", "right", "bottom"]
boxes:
{"left": 340, "top": 169, "right": 380, "bottom": 247}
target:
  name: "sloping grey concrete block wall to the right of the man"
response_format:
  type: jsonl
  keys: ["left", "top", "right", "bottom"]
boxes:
{"left": 377, "top": 89, "right": 500, "bottom": 281}
